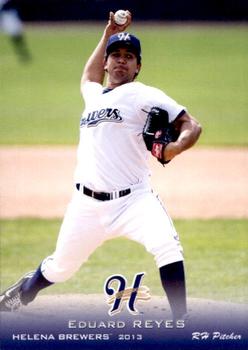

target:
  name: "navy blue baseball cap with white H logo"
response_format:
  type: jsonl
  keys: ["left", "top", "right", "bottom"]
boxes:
{"left": 106, "top": 32, "right": 141, "bottom": 63}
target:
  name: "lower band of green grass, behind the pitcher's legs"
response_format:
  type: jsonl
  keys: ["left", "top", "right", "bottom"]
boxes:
{"left": 0, "top": 219, "right": 248, "bottom": 302}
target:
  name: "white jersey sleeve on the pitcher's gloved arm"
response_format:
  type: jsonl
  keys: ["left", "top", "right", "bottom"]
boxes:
{"left": 141, "top": 87, "right": 187, "bottom": 122}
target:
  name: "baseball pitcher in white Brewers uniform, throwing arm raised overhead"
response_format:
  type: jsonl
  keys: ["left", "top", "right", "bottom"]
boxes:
{"left": 0, "top": 12, "right": 201, "bottom": 319}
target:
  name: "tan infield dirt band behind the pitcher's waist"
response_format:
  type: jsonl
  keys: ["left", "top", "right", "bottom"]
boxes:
{"left": 0, "top": 146, "right": 248, "bottom": 218}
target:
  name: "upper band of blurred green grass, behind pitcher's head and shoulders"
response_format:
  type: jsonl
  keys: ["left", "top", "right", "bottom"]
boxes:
{"left": 0, "top": 23, "right": 248, "bottom": 146}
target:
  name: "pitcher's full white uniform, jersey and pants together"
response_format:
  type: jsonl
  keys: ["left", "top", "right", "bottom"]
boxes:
{"left": 42, "top": 82, "right": 185, "bottom": 282}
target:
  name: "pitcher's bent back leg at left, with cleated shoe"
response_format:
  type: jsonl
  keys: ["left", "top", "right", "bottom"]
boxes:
{"left": 0, "top": 192, "right": 105, "bottom": 311}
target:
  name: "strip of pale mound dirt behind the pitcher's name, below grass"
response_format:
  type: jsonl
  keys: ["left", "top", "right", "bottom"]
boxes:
{"left": 2, "top": 294, "right": 248, "bottom": 326}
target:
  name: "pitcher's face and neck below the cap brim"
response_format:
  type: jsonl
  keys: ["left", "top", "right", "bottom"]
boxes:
{"left": 105, "top": 47, "right": 141, "bottom": 87}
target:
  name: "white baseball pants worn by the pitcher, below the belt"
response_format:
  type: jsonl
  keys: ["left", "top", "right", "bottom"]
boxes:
{"left": 41, "top": 184, "right": 183, "bottom": 283}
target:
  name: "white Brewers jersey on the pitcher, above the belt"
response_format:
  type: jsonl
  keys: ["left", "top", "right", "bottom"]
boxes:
{"left": 75, "top": 82, "right": 185, "bottom": 192}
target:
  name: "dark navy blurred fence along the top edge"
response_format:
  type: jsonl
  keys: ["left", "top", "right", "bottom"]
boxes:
{"left": 15, "top": 0, "right": 248, "bottom": 21}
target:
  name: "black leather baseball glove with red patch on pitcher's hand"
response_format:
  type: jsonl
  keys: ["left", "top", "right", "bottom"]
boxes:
{"left": 143, "top": 107, "right": 178, "bottom": 165}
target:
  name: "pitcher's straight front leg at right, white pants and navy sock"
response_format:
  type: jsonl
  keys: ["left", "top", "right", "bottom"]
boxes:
{"left": 120, "top": 190, "right": 187, "bottom": 319}
